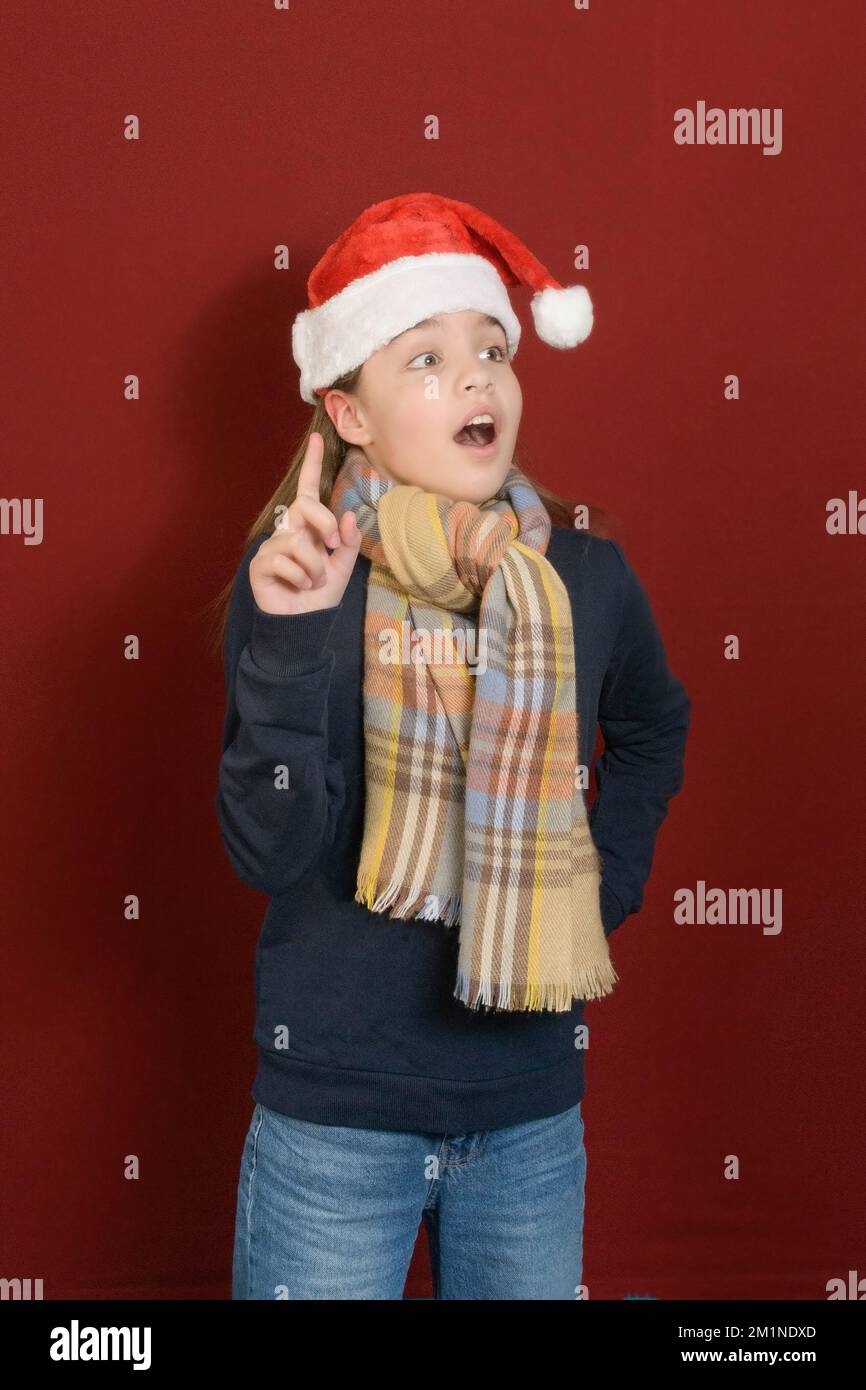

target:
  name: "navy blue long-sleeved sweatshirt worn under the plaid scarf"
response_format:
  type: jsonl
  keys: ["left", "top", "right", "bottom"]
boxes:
{"left": 217, "top": 525, "right": 691, "bottom": 1134}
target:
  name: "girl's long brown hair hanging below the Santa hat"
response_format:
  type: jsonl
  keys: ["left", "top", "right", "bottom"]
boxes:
{"left": 204, "top": 363, "right": 612, "bottom": 655}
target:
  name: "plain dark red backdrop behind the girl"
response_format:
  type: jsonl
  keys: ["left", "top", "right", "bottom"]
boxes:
{"left": 0, "top": 0, "right": 866, "bottom": 1298}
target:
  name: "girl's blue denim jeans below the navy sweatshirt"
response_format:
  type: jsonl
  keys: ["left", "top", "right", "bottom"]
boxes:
{"left": 232, "top": 1104, "right": 587, "bottom": 1300}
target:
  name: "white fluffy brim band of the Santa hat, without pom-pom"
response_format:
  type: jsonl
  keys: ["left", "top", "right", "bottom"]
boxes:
{"left": 292, "top": 252, "right": 522, "bottom": 406}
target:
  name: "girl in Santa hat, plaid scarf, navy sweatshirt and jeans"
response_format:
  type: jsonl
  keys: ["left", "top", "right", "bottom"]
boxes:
{"left": 217, "top": 193, "right": 689, "bottom": 1300}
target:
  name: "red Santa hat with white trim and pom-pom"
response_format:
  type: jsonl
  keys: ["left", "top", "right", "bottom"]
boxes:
{"left": 292, "top": 193, "right": 592, "bottom": 404}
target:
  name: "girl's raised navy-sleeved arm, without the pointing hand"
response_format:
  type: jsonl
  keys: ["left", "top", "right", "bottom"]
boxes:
{"left": 217, "top": 538, "right": 345, "bottom": 897}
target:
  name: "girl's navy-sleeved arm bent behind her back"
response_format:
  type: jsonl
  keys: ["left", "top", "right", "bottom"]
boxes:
{"left": 589, "top": 541, "right": 691, "bottom": 935}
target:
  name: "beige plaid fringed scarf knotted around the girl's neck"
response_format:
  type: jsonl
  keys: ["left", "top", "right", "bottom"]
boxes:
{"left": 331, "top": 445, "right": 619, "bottom": 1012}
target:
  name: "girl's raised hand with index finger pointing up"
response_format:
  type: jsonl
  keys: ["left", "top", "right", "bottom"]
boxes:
{"left": 250, "top": 430, "right": 361, "bottom": 614}
